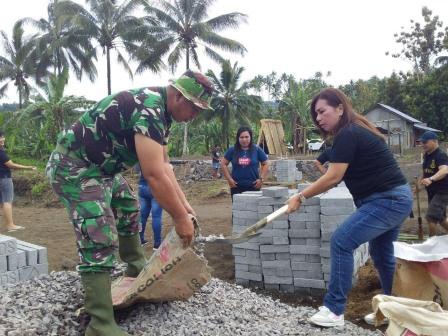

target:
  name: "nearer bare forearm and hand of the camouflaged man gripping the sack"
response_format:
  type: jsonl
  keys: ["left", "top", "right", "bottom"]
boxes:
{"left": 134, "top": 133, "right": 194, "bottom": 247}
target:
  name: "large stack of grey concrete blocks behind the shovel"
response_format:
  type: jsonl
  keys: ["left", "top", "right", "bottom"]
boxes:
{"left": 233, "top": 185, "right": 368, "bottom": 292}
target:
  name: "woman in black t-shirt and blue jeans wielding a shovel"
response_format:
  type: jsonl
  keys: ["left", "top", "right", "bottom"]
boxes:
{"left": 288, "top": 88, "right": 412, "bottom": 327}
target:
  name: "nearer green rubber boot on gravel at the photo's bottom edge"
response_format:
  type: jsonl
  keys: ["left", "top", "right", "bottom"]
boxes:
{"left": 81, "top": 272, "right": 129, "bottom": 336}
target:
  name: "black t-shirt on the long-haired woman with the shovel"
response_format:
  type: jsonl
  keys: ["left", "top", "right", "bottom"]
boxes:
{"left": 330, "top": 124, "right": 406, "bottom": 200}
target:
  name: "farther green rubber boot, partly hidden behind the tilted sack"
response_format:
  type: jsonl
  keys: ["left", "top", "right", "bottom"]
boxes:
{"left": 118, "top": 233, "right": 146, "bottom": 278}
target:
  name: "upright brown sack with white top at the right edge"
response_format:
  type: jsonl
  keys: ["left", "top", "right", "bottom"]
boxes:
{"left": 392, "top": 236, "right": 448, "bottom": 310}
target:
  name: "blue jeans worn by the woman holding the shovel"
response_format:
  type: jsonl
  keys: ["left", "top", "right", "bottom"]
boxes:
{"left": 324, "top": 184, "right": 412, "bottom": 315}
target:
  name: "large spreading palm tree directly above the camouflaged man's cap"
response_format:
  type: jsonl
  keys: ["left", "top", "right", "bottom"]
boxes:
{"left": 137, "top": 0, "right": 247, "bottom": 155}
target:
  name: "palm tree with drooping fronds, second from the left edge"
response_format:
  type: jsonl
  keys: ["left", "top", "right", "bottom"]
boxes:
{"left": 22, "top": 0, "right": 97, "bottom": 81}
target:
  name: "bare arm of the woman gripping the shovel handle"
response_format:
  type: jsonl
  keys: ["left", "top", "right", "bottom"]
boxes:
{"left": 288, "top": 163, "right": 348, "bottom": 213}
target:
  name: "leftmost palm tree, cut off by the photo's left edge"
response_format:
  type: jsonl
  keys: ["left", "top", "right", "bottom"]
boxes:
{"left": 0, "top": 21, "right": 36, "bottom": 108}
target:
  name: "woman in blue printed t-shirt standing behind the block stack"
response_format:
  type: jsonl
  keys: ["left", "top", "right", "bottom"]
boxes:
{"left": 221, "top": 126, "right": 269, "bottom": 199}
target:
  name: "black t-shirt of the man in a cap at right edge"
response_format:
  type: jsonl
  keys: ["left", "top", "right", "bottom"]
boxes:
{"left": 423, "top": 148, "right": 448, "bottom": 195}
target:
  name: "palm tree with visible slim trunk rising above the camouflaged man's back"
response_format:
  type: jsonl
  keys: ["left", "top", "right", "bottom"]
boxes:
{"left": 73, "top": 0, "right": 150, "bottom": 95}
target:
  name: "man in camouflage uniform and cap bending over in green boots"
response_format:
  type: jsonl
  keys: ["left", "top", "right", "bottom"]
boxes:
{"left": 46, "top": 71, "right": 213, "bottom": 336}
